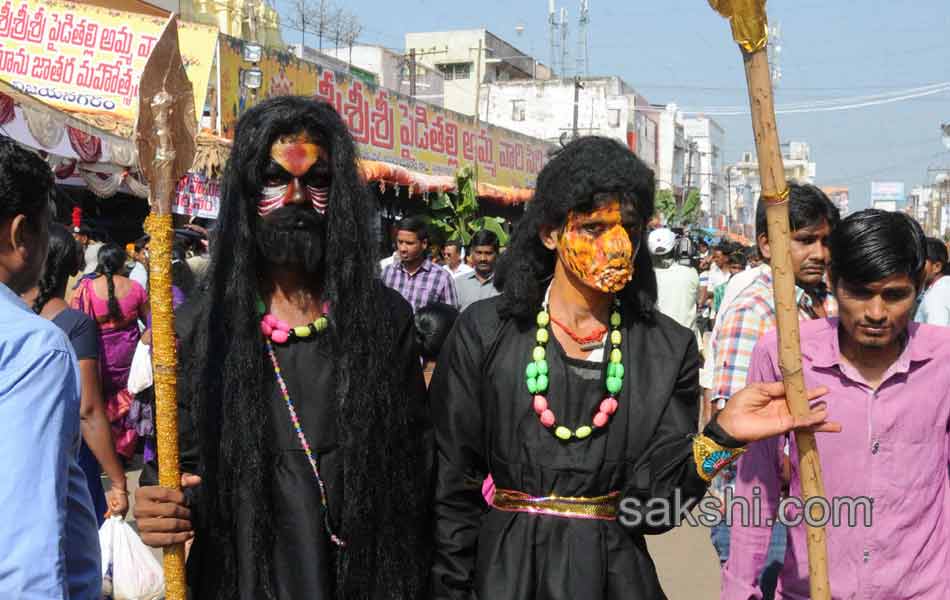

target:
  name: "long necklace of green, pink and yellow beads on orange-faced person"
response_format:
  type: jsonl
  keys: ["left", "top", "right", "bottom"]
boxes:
{"left": 525, "top": 289, "right": 624, "bottom": 442}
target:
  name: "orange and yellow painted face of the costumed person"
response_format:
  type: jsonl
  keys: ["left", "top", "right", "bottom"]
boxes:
{"left": 558, "top": 200, "right": 636, "bottom": 294}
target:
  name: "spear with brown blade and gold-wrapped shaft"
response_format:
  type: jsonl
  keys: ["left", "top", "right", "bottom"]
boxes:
{"left": 135, "top": 15, "right": 197, "bottom": 600}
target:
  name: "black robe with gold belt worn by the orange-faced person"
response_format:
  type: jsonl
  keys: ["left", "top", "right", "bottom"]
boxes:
{"left": 429, "top": 298, "right": 706, "bottom": 600}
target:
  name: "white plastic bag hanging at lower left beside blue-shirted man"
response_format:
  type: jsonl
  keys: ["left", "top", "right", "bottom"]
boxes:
{"left": 99, "top": 517, "right": 165, "bottom": 600}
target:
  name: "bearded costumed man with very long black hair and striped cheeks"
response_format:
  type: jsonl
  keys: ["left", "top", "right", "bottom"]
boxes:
{"left": 135, "top": 97, "right": 431, "bottom": 600}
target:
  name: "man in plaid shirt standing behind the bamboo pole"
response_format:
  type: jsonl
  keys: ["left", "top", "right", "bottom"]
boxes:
{"left": 711, "top": 183, "right": 840, "bottom": 562}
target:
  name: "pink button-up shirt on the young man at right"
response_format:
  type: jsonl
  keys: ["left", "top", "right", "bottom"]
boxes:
{"left": 722, "top": 319, "right": 950, "bottom": 600}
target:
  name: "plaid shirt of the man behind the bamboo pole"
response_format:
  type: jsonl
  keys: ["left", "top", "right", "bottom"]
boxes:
{"left": 712, "top": 268, "right": 838, "bottom": 399}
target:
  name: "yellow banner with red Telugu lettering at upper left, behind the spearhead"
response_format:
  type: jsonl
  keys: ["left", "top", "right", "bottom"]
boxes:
{"left": 0, "top": 0, "right": 217, "bottom": 121}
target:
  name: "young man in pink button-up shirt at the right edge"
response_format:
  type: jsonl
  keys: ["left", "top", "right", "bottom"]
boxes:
{"left": 722, "top": 210, "right": 950, "bottom": 600}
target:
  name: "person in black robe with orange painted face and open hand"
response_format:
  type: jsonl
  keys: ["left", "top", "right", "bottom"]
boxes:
{"left": 429, "top": 137, "right": 835, "bottom": 600}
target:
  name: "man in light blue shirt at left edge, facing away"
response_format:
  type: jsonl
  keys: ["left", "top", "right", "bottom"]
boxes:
{"left": 0, "top": 139, "right": 102, "bottom": 600}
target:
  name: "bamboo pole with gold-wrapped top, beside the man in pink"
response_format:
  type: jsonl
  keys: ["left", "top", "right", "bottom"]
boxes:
{"left": 709, "top": 0, "right": 831, "bottom": 600}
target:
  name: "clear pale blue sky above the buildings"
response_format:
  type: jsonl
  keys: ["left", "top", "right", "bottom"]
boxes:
{"left": 277, "top": 0, "right": 950, "bottom": 209}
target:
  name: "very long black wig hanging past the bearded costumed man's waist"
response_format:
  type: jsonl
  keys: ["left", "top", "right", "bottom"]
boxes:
{"left": 182, "top": 96, "right": 428, "bottom": 600}
